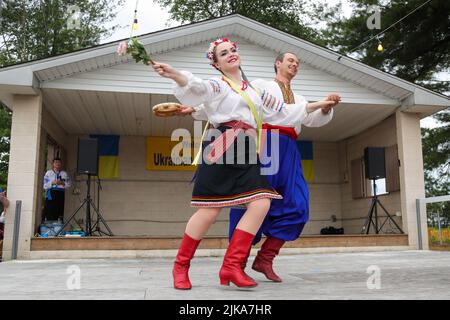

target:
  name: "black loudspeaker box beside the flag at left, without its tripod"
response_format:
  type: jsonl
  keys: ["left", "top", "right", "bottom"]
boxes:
{"left": 77, "top": 138, "right": 98, "bottom": 176}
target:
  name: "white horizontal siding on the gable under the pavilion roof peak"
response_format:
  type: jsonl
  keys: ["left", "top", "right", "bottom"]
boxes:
{"left": 43, "top": 35, "right": 398, "bottom": 105}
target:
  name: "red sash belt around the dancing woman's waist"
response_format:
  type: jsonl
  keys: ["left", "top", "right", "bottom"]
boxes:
{"left": 206, "top": 121, "right": 256, "bottom": 163}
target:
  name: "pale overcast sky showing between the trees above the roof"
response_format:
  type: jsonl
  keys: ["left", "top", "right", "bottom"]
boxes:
{"left": 102, "top": 0, "right": 450, "bottom": 128}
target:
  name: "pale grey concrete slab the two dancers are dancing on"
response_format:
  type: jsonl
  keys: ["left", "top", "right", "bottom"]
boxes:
{"left": 0, "top": 251, "right": 450, "bottom": 300}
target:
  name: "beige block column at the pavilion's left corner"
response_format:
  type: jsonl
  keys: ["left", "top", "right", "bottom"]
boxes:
{"left": 3, "top": 95, "right": 42, "bottom": 260}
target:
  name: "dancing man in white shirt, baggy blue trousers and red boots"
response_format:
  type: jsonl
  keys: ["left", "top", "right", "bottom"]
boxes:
{"left": 229, "top": 53, "right": 341, "bottom": 282}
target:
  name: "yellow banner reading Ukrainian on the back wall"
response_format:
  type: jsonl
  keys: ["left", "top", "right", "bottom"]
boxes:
{"left": 147, "top": 137, "right": 197, "bottom": 171}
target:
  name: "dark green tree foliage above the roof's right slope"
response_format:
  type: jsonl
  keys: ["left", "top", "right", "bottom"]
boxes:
{"left": 323, "top": 0, "right": 450, "bottom": 92}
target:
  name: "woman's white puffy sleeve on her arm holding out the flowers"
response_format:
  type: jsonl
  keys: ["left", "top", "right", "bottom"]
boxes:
{"left": 174, "top": 71, "right": 229, "bottom": 107}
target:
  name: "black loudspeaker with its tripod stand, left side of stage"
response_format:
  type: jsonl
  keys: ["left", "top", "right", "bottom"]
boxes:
{"left": 56, "top": 138, "right": 113, "bottom": 236}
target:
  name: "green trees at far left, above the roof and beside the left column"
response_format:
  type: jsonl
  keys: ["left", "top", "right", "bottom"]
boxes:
{"left": 0, "top": 0, "right": 123, "bottom": 186}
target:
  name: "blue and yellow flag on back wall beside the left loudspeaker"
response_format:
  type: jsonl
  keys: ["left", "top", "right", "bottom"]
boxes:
{"left": 91, "top": 135, "right": 120, "bottom": 179}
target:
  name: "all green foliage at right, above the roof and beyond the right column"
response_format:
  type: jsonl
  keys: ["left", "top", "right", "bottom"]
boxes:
{"left": 323, "top": 0, "right": 450, "bottom": 224}
